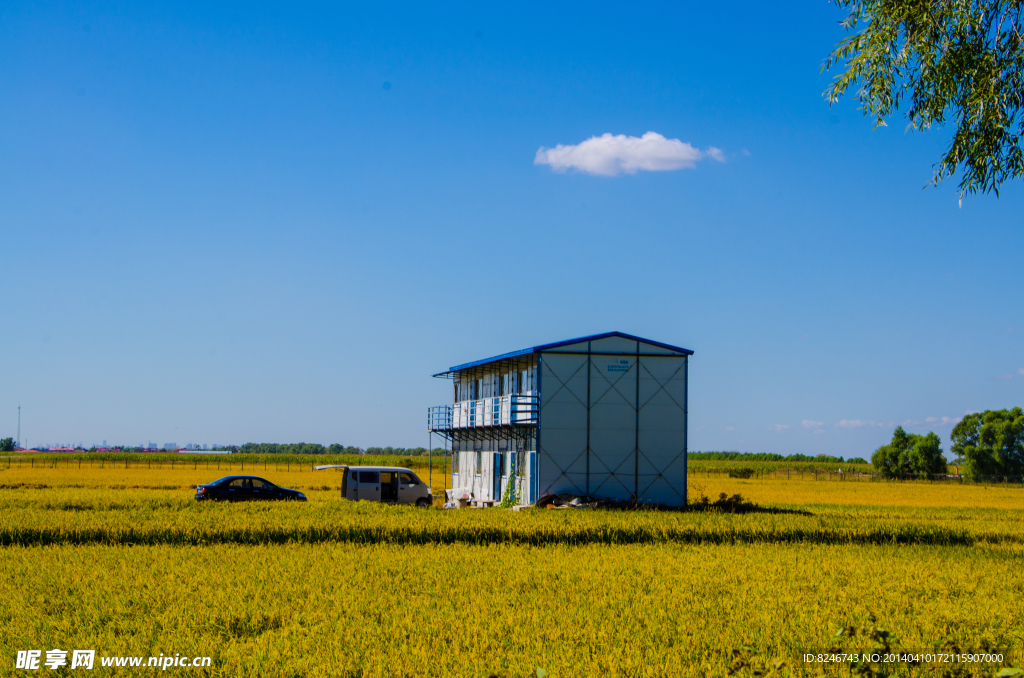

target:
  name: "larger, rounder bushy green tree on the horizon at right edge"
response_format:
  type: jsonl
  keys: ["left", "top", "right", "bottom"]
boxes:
{"left": 949, "top": 408, "right": 1024, "bottom": 475}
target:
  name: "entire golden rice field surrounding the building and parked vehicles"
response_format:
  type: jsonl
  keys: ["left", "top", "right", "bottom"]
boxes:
{"left": 0, "top": 468, "right": 1024, "bottom": 678}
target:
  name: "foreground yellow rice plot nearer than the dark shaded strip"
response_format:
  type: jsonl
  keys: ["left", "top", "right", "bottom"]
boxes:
{"left": 0, "top": 544, "right": 1024, "bottom": 678}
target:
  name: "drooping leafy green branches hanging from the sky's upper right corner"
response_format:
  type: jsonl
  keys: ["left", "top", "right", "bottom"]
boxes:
{"left": 823, "top": 0, "right": 1024, "bottom": 200}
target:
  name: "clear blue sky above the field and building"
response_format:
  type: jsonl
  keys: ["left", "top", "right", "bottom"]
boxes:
{"left": 0, "top": 2, "right": 1024, "bottom": 457}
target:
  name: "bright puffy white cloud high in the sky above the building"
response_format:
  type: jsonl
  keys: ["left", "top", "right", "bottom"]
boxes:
{"left": 534, "top": 132, "right": 725, "bottom": 176}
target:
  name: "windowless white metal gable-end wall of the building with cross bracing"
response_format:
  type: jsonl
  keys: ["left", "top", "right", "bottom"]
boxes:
{"left": 538, "top": 337, "right": 687, "bottom": 506}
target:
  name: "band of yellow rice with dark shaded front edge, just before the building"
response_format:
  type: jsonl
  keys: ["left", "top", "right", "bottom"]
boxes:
{"left": 0, "top": 489, "right": 1024, "bottom": 546}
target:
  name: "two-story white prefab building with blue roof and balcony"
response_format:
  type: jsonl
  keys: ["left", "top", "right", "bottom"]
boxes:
{"left": 428, "top": 332, "right": 693, "bottom": 506}
